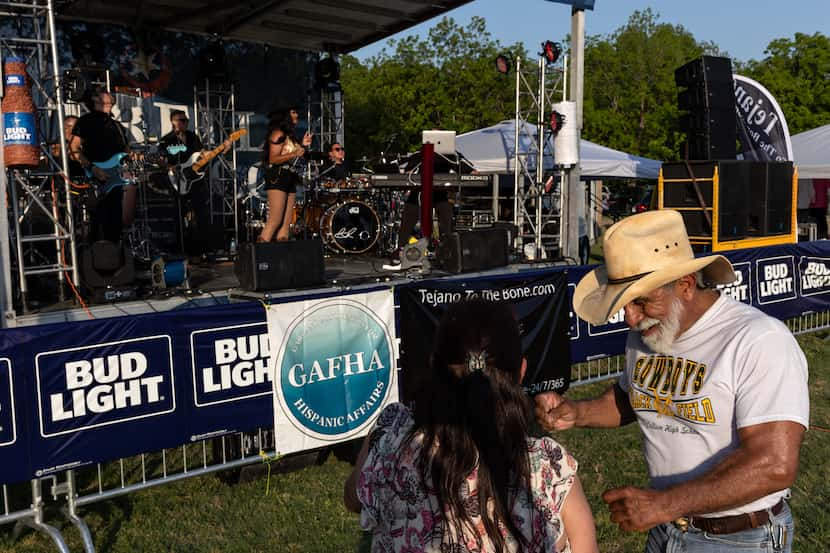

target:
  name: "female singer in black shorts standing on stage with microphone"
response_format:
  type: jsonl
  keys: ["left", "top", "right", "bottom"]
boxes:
{"left": 257, "top": 108, "right": 311, "bottom": 242}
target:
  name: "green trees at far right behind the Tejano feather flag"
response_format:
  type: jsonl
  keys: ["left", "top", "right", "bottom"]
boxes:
{"left": 741, "top": 33, "right": 830, "bottom": 134}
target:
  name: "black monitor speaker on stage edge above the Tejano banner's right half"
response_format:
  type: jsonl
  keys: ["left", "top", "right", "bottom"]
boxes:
{"left": 437, "top": 228, "right": 510, "bottom": 273}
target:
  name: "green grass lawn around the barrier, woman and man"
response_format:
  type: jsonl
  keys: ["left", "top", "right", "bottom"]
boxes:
{"left": 0, "top": 332, "right": 830, "bottom": 553}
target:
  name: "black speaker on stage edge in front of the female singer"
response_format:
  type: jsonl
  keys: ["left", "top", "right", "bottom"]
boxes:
{"left": 234, "top": 240, "right": 325, "bottom": 292}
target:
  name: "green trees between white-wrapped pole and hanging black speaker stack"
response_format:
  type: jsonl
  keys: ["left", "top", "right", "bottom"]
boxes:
{"left": 582, "top": 9, "right": 718, "bottom": 160}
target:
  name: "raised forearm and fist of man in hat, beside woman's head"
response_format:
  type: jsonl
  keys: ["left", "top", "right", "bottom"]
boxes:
{"left": 536, "top": 384, "right": 634, "bottom": 432}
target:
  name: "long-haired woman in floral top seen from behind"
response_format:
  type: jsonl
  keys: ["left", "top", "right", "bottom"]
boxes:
{"left": 344, "top": 300, "right": 597, "bottom": 553}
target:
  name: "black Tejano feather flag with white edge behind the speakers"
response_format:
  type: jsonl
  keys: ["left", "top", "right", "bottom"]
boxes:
{"left": 733, "top": 75, "right": 793, "bottom": 161}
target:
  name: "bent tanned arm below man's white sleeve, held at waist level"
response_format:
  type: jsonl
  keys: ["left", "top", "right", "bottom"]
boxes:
{"left": 602, "top": 421, "right": 804, "bottom": 531}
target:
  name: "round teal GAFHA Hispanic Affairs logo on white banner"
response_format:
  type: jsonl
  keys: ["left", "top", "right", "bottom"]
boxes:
{"left": 277, "top": 299, "right": 394, "bottom": 440}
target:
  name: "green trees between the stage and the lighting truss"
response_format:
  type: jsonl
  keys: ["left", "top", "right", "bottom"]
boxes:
{"left": 341, "top": 17, "right": 524, "bottom": 159}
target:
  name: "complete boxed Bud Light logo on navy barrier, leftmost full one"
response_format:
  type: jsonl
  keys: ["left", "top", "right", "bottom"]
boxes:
{"left": 35, "top": 336, "right": 175, "bottom": 436}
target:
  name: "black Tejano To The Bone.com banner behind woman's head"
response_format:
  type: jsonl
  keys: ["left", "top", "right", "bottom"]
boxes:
{"left": 396, "top": 269, "right": 571, "bottom": 399}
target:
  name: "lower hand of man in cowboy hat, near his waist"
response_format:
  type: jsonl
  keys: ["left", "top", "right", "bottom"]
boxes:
{"left": 602, "top": 486, "right": 679, "bottom": 532}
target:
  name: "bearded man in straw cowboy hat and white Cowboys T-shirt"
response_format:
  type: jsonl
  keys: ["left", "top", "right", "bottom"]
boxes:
{"left": 536, "top": 211, "right": 809, "bottom": 553}
